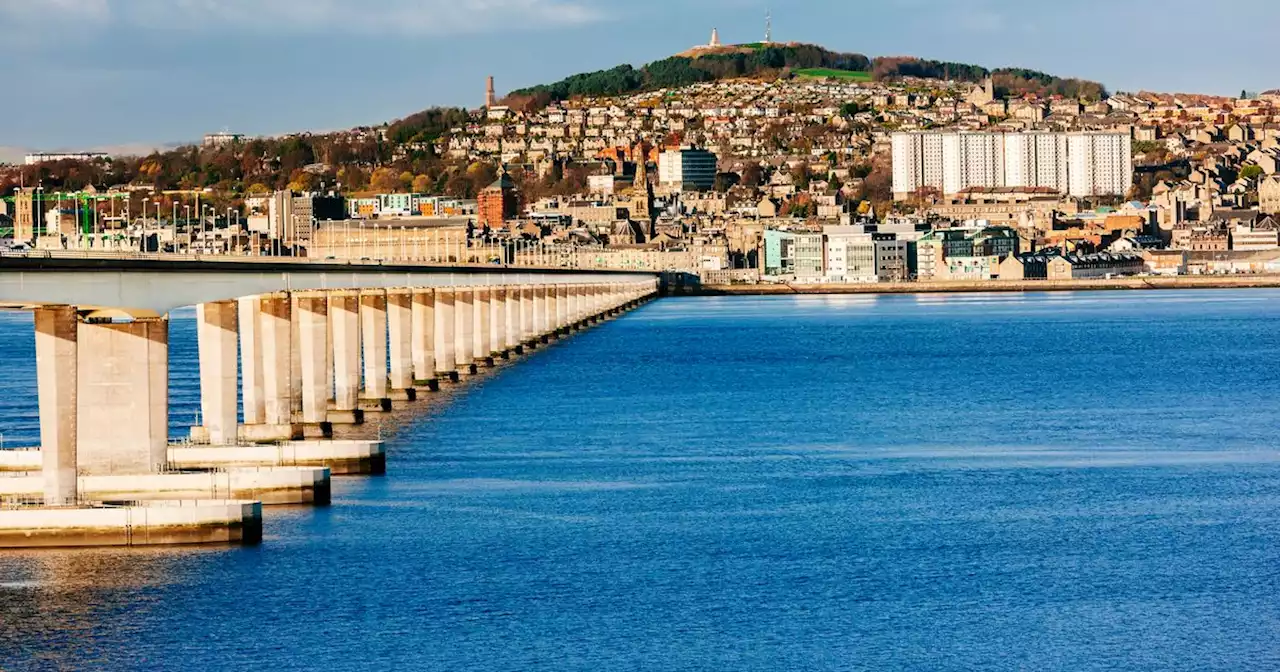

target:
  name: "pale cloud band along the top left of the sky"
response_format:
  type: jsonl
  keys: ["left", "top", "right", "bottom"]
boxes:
{"left": 0, "top": 0, "right": 607, "bottom": 36}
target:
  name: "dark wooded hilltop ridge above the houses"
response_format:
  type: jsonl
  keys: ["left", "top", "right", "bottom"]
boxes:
{"left": 507, "top": 44, "right": 1107, "bottom": 109}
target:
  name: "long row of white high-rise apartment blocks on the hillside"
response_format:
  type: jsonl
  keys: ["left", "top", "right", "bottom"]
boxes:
{"left": 892, "top": 132, "right": 1133, "bottom": 200}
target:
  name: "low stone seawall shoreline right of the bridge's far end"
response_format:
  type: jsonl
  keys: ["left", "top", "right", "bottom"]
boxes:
{"left": 691, "top": 275, "right": 1280, "bottom": 296}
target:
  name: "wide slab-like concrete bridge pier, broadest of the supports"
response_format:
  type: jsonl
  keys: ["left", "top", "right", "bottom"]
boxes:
{"left": 77, "top": 319, "right": 169, "bottom": 475}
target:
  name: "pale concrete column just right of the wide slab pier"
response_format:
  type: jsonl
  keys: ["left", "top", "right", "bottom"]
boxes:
{"left": 196, "top": 301, "right": 239, "bottom": 445}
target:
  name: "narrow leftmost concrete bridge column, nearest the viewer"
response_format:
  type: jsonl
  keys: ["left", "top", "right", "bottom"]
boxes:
{"left": 36, "top": 306, "right": 79, "bottom": 506}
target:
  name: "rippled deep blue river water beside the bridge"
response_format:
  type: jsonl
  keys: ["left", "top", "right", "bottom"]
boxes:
{"left": 0, "top": 291, "right": 1280, "bottom": 671}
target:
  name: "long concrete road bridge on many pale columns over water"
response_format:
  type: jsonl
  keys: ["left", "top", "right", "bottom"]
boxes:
{"left": 0, "top": 255, "right": 659, "bottom": 548}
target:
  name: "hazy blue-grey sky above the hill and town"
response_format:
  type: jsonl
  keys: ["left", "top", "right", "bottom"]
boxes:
{"left": 0, "top": 0, "right": 1280, "bottom": 150}
